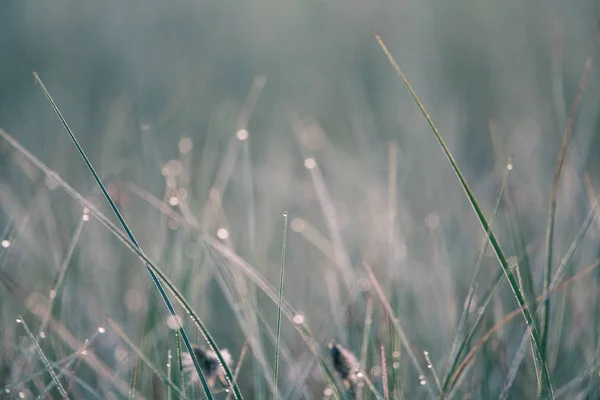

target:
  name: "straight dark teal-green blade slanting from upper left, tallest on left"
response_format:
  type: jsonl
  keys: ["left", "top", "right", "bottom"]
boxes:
{"left": 33, "top": 71, "right": 230, "bottom": 400}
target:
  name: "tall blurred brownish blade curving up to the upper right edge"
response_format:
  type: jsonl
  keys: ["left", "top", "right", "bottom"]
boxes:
{"left": 541, "top": 20, "right": 600, "bottom": 366}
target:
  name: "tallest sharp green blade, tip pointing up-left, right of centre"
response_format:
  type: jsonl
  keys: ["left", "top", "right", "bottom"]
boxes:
{"left": 375, "top": 34, "right": 554, "bottom": 398}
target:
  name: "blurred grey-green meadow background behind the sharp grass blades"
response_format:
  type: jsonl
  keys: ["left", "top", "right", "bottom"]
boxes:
{"left": 0, "top": 0, "right": 600, "bottom": 399}
